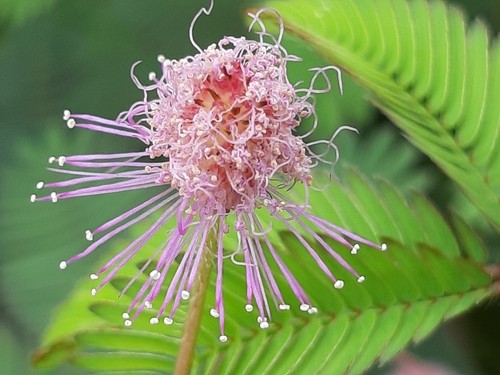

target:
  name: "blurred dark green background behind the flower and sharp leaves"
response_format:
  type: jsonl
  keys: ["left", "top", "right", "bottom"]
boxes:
{"left": 0, "top": 0, "right": 500, "bottom": 375}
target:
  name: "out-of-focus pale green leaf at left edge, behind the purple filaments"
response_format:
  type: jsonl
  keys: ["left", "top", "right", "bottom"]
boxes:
{"left": 0, "top": 126, "right": 146, "bottom": 334}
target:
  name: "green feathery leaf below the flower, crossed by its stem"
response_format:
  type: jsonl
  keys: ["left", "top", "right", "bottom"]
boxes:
{"left": 35, "top": 170, "right": 491, "bottom": 374}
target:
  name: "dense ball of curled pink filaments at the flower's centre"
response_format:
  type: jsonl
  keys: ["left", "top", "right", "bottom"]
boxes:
{"left": 148, "top": 37, "right": 312, "bottom": 214}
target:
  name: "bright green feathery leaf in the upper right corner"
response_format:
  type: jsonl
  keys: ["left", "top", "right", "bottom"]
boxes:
{"left": 266, "top": 0, "right": 500, "bottom": 227}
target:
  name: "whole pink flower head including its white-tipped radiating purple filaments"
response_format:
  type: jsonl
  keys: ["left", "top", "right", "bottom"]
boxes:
{"left": 31, "top": 4, "right": 386, "bottom": 342}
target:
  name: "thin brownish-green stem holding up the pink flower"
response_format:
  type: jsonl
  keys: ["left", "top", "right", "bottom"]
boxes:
{"left": 174, "top": 236, "right": 215, "bottom": 375}
